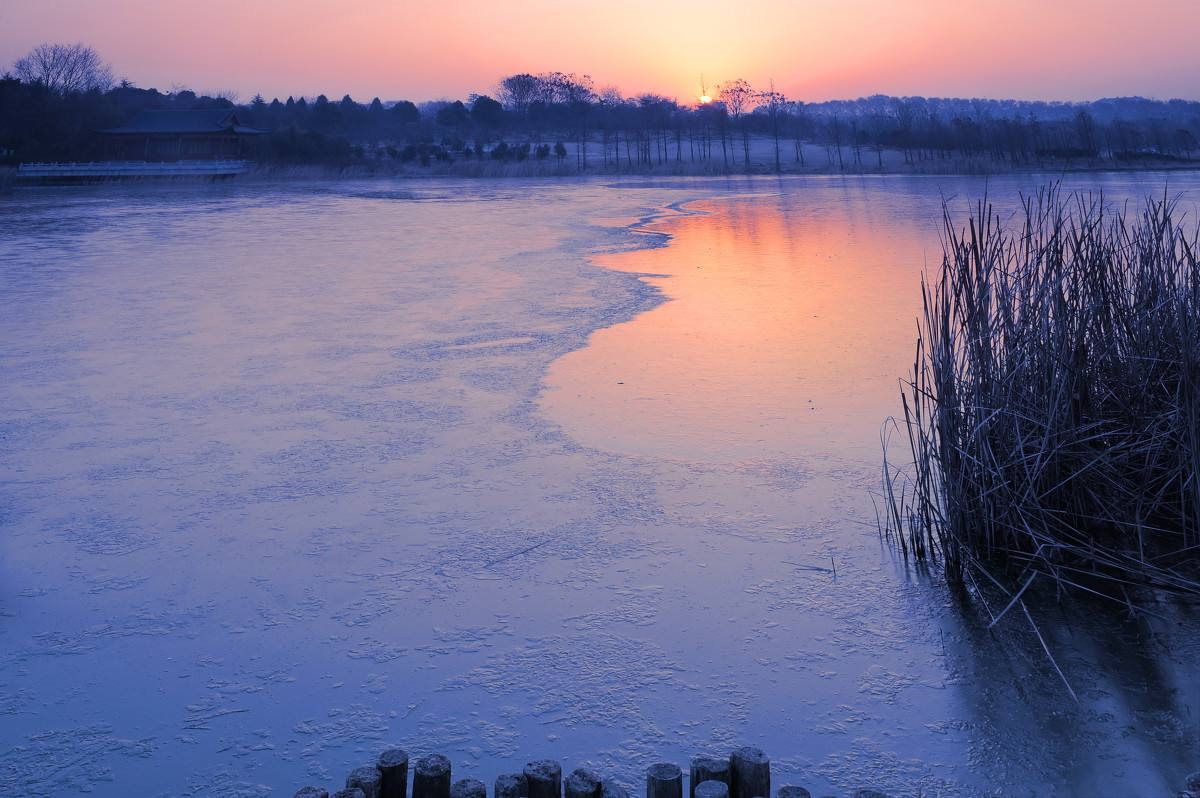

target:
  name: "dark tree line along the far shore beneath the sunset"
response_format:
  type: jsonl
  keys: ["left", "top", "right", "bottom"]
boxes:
{"left": 0, "top": 44, "right": 1200, "bottom": 172}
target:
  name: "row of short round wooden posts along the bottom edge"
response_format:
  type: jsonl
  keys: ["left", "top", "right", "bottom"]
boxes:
{"left": 295, "top": 746, "right": 887, "bottom": 798}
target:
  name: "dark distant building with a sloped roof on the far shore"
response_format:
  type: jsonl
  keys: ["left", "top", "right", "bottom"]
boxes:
{"left": 100, "top": 108, "right": 266, "bottom": 161}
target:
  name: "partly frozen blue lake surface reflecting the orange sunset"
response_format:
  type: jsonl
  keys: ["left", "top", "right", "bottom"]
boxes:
{"left": 0, "top": 174, "right": 1200, "bottom": 797}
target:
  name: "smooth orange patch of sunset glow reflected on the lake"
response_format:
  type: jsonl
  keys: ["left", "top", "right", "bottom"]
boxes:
{"left": 544, "top": 192, "right": 930, "bottom": 460}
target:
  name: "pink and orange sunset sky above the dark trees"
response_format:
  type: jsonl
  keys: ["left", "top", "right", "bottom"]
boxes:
{"left": 0, "top": 0, "right": 1200, "bottom": 102}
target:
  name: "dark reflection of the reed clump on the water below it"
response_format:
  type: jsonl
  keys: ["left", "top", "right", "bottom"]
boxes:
{"left": 942, "top": 583, "right": 1200, "bottom": 796}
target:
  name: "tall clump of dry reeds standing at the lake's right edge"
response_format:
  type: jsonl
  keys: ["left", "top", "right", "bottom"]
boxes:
{"left": 882, "top": 187, "right": 1200, "bottom": 607}
